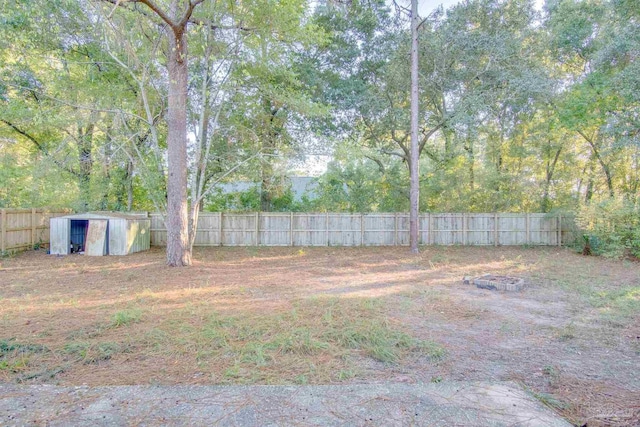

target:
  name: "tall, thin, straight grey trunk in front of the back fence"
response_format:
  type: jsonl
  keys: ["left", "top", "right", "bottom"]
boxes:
{"left": 409, "top": 0, "right": 420, "bottom": 254}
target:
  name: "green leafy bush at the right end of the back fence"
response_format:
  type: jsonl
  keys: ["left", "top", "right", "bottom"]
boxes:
{"left": 576, "top": 199, "right": 640, "bottom": 258}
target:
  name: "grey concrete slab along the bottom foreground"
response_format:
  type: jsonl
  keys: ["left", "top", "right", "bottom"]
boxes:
{"left": 0, "top": 383, "right": 570, "bottom": 427}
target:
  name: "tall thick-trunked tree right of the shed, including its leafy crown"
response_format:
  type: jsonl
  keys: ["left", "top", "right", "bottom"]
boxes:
{"left": 105, "top": 0, "right": 318, "bottom": 258}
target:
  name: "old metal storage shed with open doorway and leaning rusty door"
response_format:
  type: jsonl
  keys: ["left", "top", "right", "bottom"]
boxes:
{"left": 50, "top": 212, "right": 151, "bottom": 256}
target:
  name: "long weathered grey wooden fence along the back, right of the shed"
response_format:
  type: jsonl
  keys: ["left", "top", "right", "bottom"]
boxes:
{"left": 150, "top": 212, "right": 573, "bottom": 246}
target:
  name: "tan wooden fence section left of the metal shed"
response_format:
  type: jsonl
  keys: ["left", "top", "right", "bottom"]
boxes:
{"left": 0, "top": 208, "right": 69, "bottom": 253}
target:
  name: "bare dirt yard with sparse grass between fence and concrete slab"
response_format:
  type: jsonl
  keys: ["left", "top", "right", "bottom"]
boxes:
{"left": 0, "top": 247, "right": 640, "bottom": 426}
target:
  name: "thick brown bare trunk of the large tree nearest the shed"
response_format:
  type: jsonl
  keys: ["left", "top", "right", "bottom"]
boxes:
{"left": 165, "top": 28, "right": 191, "bottom": 267}
